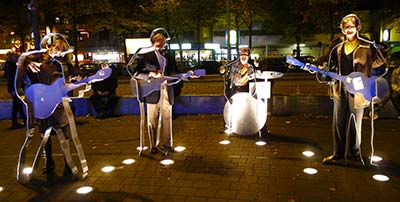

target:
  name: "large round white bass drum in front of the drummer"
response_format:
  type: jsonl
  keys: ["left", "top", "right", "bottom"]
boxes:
{"left": 224, "top": 93, "right": 267, "bottom": 135}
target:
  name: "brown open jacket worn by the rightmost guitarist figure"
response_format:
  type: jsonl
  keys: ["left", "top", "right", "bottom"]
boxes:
{"left": 324, "top": 37, "right": 386, "bottom": 97}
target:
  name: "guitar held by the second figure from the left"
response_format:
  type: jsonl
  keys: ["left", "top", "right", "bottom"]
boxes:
{"left": 131, "top": 69, "right": 206, "bottom": 98}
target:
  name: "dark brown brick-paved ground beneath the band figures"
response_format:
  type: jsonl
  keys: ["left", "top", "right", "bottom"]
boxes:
{"left": 0, "top": 115, "right": 400, "bottom": 202}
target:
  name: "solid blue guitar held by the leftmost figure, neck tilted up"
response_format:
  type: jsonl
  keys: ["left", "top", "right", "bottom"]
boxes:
{"left": 25, "top": 68, "right": 112, "bottom": 119}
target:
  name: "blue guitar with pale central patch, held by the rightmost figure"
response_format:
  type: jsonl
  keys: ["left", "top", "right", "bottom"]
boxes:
{"left": 286, "top": 56, "right": 389, "bottom": 103}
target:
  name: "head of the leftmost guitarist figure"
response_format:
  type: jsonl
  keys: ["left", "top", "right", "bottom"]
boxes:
{"left": 40, "top": 33, "right": 70, "bottom": 55}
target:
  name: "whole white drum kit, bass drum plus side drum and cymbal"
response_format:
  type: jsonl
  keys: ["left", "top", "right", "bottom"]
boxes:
{"left": 224, "top": 71, "right": 283, "bottom": 136}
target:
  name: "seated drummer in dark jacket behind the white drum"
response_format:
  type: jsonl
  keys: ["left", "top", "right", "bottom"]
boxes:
{"left": 219, "top": 47, "right": 256, "bottom": 135}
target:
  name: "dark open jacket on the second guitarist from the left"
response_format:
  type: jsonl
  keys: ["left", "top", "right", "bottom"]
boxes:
{"left": 134, "top": 50, "right": 179, "bottom": 105}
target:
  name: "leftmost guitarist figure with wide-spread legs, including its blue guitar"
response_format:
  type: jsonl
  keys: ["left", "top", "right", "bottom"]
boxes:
{"left": 15, "top": 33, "right": 111, "bottom": 184}
